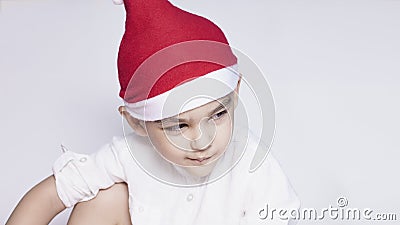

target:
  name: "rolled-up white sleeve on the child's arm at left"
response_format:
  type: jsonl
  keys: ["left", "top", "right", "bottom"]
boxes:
{"left": 53, "top": 138, "right": 126, "bottom": 207}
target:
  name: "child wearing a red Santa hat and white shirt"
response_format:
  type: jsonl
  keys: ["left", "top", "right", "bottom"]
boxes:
{"left": 7, "top": 0, "right": 299, "bottom": 225}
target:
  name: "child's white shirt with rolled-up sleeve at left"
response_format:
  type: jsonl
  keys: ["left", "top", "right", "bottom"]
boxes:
{"left": 53, "top": 125, "right": 300, "bottom": 225}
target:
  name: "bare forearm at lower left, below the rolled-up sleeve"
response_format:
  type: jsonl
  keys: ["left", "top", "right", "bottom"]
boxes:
{"left": 6, "top": 176, "right": 65, "bottom": 225}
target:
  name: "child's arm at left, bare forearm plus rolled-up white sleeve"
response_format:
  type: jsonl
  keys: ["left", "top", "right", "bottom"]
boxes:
{"left": 7, "top": 138, "right": 129, "bottom": 225}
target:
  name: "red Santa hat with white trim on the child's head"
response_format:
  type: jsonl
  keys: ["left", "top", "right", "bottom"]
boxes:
{"left": 114, "top": 0, "right": 239, "bottom": 121}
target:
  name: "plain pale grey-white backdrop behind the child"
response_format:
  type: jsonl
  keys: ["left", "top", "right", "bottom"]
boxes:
{"left": 0, "top": 0, "right": 400, "bottom": 224}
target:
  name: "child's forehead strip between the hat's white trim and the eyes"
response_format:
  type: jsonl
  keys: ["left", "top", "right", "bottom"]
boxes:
{"left": 154, "top": 93, "right": 232, "bottom": 123}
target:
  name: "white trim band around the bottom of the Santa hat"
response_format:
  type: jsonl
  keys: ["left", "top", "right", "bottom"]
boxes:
{"left": 124, "top": 64, "right": 240, "bottom": 121}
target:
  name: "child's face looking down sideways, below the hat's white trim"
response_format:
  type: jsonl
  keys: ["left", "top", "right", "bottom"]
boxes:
{"left": 120, "top": 84, "right": 238, "bottom": 176}
